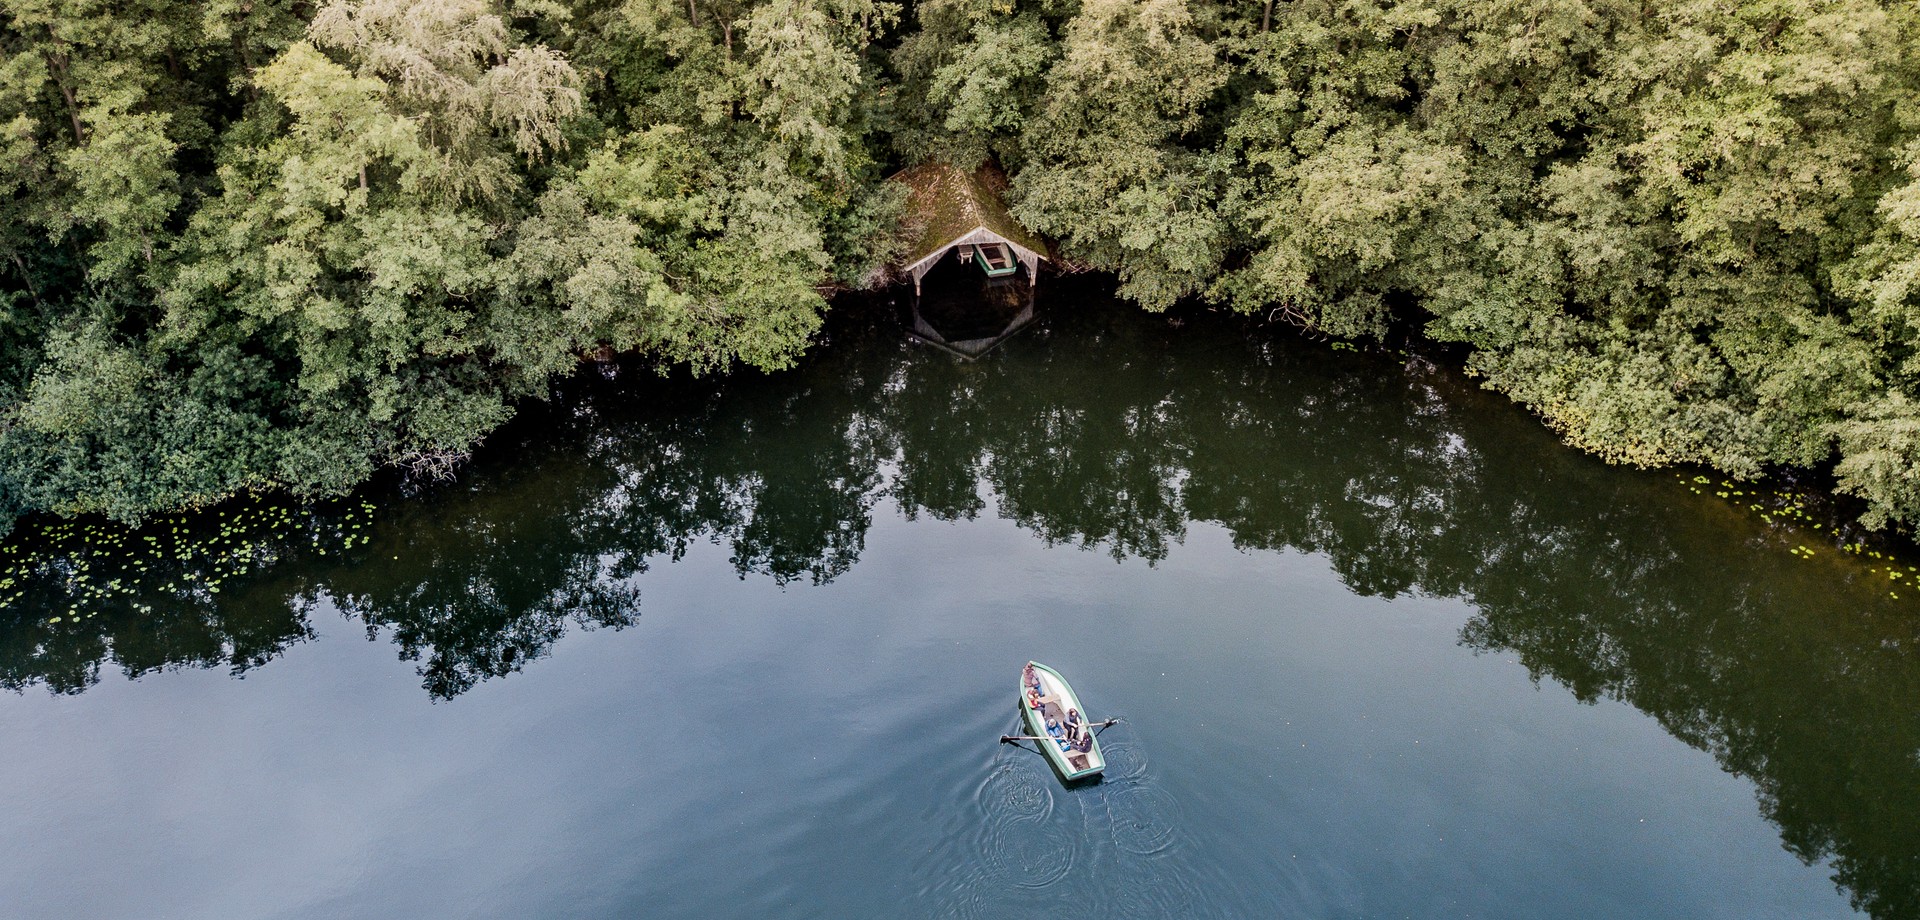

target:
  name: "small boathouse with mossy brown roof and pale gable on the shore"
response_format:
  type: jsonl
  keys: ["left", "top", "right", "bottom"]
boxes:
{"left": 889, "top": 163, "right": 1048, "bottom": 294}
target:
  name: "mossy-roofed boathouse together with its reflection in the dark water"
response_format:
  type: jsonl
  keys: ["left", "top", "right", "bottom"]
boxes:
{"left": 891, "top": 163, "right": 1048, "bottom": 361}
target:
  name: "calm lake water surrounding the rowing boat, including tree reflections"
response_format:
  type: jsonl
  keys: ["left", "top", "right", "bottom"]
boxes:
{"left": 0, "top": 286, "right": 1920, "bottom": 920}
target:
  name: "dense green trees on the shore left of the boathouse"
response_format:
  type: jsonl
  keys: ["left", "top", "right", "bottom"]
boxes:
{"left": 0, "top": 0, "right": 899, "bottom": 526}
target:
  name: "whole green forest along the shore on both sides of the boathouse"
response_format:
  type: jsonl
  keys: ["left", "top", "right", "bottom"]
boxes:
{"left": 0, "top": 0, "right": 1920, "bottom": 541}
